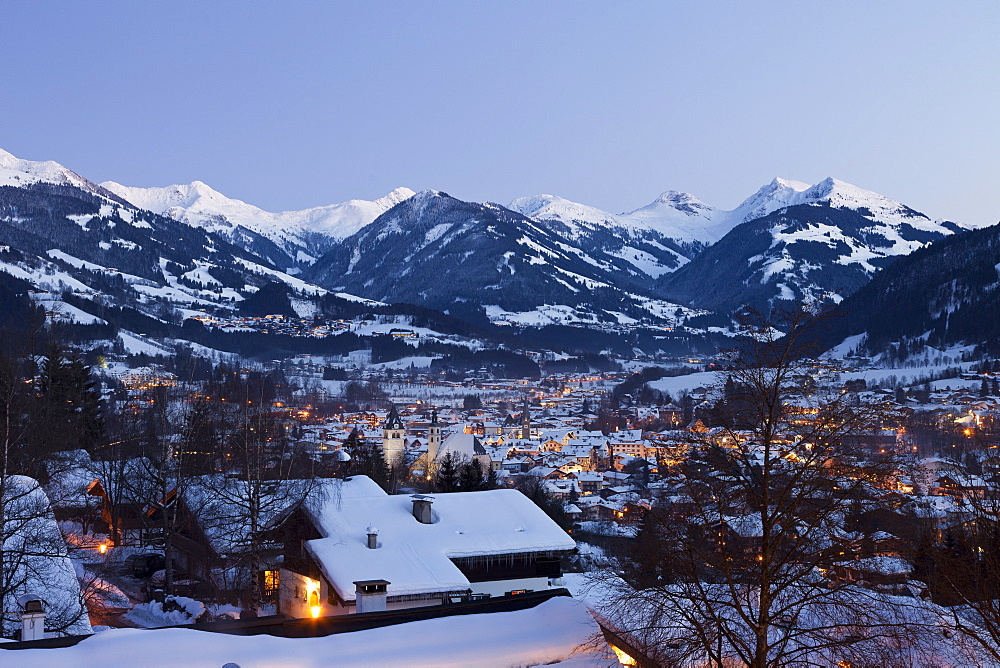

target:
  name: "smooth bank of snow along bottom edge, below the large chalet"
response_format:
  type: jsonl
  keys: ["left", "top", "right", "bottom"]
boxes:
{"left": 9, "top": 597, "right": 617, "bottom": 668}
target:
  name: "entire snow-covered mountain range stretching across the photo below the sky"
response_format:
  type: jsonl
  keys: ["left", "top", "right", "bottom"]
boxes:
{"left": 0, "top": 146, "right": 984, "bottom": 334}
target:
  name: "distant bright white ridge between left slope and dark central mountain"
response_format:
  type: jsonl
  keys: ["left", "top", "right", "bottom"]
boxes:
{"left": 101, "top": 181, "right": 413, "bottom": 266}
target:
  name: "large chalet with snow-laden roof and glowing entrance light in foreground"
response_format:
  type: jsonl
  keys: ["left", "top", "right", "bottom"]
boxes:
{"left": 279, "top": 476, "right": 576, "bottom": 617}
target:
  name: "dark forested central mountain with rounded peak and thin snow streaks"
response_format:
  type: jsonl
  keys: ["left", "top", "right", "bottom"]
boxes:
{"left": 305, "top": 191, "right": 700, "bottom": 323}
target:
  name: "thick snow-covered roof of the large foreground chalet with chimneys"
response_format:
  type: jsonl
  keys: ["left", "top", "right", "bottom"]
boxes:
{"left": 306, "top": 489, "right": 576, "bottom": 601}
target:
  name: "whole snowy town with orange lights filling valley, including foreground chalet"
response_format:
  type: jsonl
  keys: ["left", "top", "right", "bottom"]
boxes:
{"left": 4, "top": 310, "right": 1000, "bottom": 665}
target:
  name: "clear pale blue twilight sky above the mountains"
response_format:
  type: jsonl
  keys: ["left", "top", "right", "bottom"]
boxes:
{"left": 0, "top": 0, "right": 1000, "bottom": 224}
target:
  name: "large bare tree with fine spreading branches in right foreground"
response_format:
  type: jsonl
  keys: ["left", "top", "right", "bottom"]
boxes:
{"left": 600, "top": 311, "right": 915, "bottom": 668}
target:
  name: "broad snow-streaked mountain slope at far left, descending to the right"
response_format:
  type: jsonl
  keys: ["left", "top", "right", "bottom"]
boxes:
{"left": 0, "top": 152, "right": 348, "bottom": 328}
